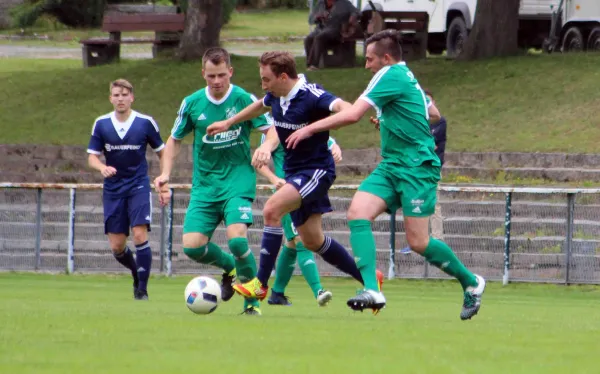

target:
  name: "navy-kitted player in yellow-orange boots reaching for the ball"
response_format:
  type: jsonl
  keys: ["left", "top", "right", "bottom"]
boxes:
{"left": 207, "top": 51, "right": 383, "bottom": 306}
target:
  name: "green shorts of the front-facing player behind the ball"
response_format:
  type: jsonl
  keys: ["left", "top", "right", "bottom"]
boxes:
{"left": 183, "top": 195, "right": 252, "bottom": 238}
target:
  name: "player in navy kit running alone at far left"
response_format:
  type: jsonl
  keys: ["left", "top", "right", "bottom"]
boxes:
{"left": 87, "top": 79, "right": 165, "bottom": 300}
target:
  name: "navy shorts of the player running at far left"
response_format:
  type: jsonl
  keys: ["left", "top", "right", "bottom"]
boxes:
{"left": 102, "top": 191, "right": 152, "bottom": 236}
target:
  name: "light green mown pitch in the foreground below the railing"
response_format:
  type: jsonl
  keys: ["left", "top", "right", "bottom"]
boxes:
{"left": 0, "top": 273, "right": 600, "bottom": 374}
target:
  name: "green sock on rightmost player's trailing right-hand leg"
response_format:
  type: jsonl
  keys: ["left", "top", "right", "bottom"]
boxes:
{"left": 423, "top": 238, "right": 477, "bottom": 289}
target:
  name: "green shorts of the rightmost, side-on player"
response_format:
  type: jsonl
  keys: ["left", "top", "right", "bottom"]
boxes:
{"left": 358, "top": 164, "right": 440, "bottom": 217}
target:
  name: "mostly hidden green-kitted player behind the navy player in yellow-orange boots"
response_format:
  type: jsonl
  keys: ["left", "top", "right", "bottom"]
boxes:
{"left": 256, "top": 136, "right": 342, "bottom": 306}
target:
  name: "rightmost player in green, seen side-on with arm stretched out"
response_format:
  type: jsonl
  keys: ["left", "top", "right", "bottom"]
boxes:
{"left": 286, "top": 30, "right": 485, "bottom": 320}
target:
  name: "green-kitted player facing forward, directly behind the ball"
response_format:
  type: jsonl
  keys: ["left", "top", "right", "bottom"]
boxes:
{"left": 155, "top": 48, "right": 278, "bottom": 315}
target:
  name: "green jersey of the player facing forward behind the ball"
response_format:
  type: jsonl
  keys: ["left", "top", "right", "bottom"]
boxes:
{"left": 171, "top": 85, "right": 271, "bottom": 202}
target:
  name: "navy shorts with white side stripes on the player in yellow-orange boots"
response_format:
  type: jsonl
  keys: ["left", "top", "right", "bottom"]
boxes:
{"left": 285, "top": 169, "right": 335, "bottom": 227}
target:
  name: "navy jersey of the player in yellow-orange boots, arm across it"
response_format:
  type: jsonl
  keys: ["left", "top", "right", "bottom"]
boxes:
{"left": 263, "top": 74, "right": 338, "bottom": 174}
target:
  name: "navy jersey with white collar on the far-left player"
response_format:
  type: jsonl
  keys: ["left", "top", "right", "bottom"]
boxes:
{"left": 88, "top": 112, "right": 165, "bottom": 197}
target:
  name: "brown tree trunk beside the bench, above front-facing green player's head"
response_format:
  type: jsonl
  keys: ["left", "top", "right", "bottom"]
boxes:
{"left": 178, "top": 0, "right": 223, "bottom": 61}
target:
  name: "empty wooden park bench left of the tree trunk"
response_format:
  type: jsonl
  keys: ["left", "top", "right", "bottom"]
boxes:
{"left": 80, "top": 14, "right": 185, "bottom": 67}
